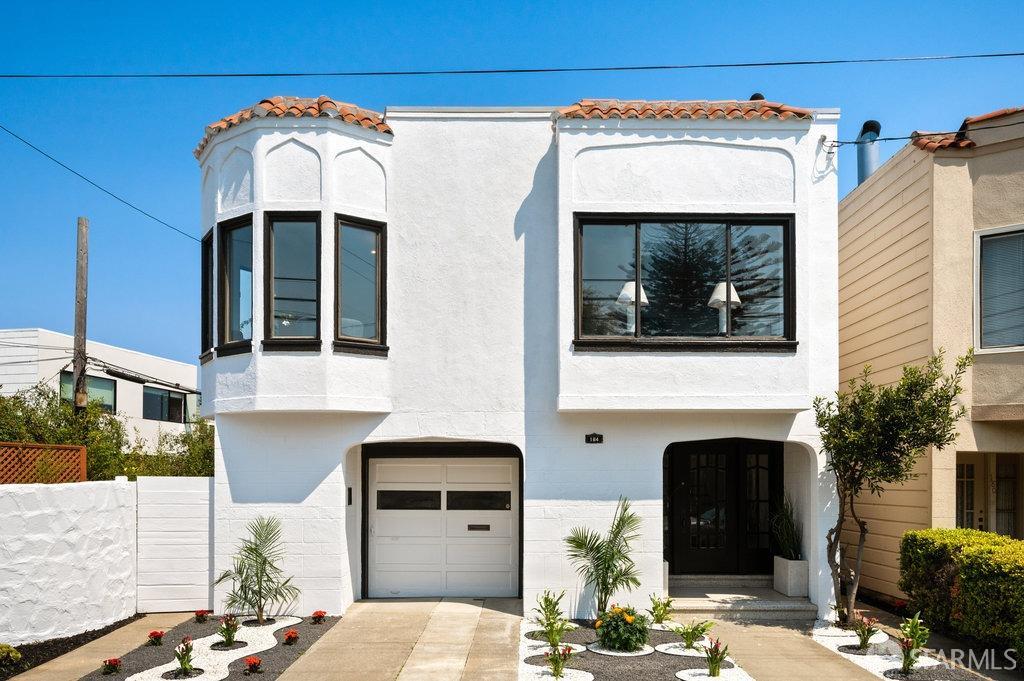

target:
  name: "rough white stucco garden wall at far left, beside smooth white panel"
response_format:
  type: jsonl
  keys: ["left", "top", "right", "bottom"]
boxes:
{"left": 0, "top": 481, "right": 136, "bottom": 645}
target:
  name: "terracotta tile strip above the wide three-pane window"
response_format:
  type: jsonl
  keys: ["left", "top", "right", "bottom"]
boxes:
{"left": 556, "top": 99, "right": 813, "bottom": 121}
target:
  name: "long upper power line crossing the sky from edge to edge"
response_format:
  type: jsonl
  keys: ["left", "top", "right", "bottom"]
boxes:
{"left": 0, "top": 52, "right": 1024, "bottom": 80}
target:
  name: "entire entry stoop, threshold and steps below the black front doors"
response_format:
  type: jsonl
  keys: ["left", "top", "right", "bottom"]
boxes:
{"left": 669, "top": 574, "right": 818, "bottom": 623}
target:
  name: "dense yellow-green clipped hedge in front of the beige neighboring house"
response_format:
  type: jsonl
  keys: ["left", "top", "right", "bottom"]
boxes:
{"left": 899, "top": 529, "right": 1024, "bottom": 649}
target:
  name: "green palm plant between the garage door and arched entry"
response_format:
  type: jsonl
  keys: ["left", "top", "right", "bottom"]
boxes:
{"left": 565, "top": 497, "right": 640, "bottom": 612}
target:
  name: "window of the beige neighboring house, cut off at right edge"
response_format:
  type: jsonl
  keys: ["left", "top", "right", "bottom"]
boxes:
{"left": 980, "top": 231, "right": 1024, "bottom": 348}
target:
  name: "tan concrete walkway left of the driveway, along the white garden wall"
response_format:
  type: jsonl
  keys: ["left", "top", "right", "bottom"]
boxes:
{"left": 14, "top": 612, "right": 193, "bottom": 681}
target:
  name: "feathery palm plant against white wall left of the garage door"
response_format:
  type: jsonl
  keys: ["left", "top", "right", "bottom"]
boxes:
{"left": 213, "top": 517, "right": 299, "bottom": 625}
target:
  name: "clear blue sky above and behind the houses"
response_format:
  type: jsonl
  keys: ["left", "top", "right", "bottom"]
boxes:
{"left": 0, "top": 0, "right": 1024, "bottom": 361}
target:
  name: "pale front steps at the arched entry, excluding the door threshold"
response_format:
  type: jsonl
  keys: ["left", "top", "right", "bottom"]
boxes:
{"left": 670, "top": 585, "right": 818, "bottom": 623}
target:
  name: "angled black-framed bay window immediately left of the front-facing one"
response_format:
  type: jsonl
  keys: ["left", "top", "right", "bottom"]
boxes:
{"left": 218, "top": 215, "right": 253, "bottom": 351}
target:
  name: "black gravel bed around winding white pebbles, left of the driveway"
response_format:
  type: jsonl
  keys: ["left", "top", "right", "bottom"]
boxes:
{"left": 81, "top": 618, "right": 341, "bottom": 681}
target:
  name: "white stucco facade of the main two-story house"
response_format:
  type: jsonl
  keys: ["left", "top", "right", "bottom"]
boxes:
{"left": 201, "top": 103, "right": 838, "bottom": 615}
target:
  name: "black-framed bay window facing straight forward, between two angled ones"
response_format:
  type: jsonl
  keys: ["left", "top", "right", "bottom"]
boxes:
{"left": 263, "top": 212, "right": 321, "bottom": 350}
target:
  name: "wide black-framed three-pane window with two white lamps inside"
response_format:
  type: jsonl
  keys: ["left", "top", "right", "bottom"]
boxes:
{"left": 573, "top": 214, "right": 796, "bottom": 350}
